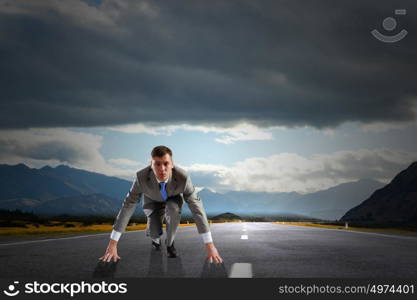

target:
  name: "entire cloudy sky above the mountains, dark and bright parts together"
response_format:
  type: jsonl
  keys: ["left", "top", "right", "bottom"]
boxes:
{"left": 0, "top": 0, "right": 417, "bottom": 193}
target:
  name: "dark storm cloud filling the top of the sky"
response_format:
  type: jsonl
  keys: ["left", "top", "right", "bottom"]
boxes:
{"left": 0, "top": 0, "right": 417, "bottom": 128}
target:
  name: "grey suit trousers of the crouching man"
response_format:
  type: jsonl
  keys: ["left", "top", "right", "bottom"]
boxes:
{"left": 146, "top": 195, "right": 183, "bottom": 246}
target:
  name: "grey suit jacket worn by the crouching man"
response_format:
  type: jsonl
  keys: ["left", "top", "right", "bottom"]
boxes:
{"left": 113, "top": 166, "right": 210, "bottom": 233}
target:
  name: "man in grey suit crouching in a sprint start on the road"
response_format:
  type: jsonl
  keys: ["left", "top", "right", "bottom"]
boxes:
{"left": 99, "top": 146, "right": 223, "bottom": 263}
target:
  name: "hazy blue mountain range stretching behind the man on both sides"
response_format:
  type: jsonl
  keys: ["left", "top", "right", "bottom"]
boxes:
{"left": 0, "top": 164, "right": 383, "bottom": 220}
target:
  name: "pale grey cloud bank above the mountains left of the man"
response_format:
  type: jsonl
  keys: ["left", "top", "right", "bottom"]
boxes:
{"left": 0, "top": 128, "right": 143, "bottom": 180}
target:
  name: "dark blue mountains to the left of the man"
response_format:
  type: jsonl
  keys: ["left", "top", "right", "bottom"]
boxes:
{"left": 0, "top": 164, "right": 135, "bottom": 215}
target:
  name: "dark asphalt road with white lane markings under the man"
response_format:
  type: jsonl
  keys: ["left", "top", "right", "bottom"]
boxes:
{"left": 0, "top": 223, "right": 417, "bottom": 280}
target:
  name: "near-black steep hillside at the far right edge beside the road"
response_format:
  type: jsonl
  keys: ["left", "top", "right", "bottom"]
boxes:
{"left": 341, "top": 162, "right": 417, "bottom": 224}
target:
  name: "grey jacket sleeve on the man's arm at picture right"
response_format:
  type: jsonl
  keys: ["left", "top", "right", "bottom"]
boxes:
{"left": 183, "top": 175, "right": 210, "bottom": 234}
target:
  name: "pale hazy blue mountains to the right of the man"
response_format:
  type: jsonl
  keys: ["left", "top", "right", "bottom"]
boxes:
{"left": 183, "top": 179, "right": 383, "bottom": 220}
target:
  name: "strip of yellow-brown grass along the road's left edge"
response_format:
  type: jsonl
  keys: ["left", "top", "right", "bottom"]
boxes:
{"left": 0, "top": 222, "right": 195, "bottom": 237}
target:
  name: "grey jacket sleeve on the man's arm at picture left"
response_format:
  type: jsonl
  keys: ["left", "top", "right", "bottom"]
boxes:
{"left": 113, "top": 176, "right": 142, "bottom": 232}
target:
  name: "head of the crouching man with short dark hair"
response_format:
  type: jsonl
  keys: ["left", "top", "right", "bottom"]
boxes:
{"left": 151, "top": 146, "right": 174, "bottom": 181}
